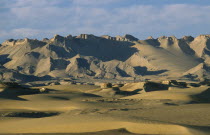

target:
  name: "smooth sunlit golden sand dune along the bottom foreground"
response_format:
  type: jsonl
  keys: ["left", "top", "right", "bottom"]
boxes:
{"left": 1, "top": 117, "right": 205, "bottom": 135}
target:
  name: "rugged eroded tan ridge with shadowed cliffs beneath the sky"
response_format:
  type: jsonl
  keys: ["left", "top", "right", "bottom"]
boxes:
{"left": 0, "top": 34, "right": 210, "bottom": 79}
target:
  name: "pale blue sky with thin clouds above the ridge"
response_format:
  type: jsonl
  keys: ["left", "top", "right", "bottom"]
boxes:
{"left": 0, "top": 0, "right": 210, "bottom": 42}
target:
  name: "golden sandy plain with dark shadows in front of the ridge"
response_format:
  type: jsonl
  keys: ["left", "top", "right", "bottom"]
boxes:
{"left": 0, "top": 84, "right": 210, "bottom": 135}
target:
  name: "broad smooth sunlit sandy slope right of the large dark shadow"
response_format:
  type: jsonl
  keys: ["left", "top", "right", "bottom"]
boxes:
{"left": 133, "top": 37, "right": 201, "bottom": 76}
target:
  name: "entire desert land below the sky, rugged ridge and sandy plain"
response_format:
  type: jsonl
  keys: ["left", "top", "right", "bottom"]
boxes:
{"left": 0, "top": 34, "right": 210, "bottom": 135}
